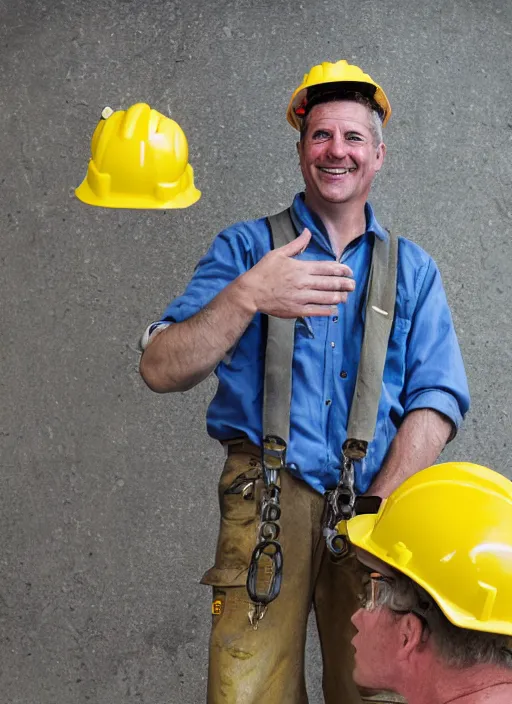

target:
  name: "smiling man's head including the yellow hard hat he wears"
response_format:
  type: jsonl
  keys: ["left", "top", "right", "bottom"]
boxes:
{"left": 287, "top": 61, "right": 391, "bottom": 207}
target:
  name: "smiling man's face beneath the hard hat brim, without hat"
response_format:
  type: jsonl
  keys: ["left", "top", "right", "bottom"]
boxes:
{"left": 298, "top": 100, "right": 386, "bottom": 212}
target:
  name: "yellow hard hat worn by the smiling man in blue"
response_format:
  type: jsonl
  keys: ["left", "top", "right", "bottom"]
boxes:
{"left": 286, "top": 59, "right": 391, "bottom": 130}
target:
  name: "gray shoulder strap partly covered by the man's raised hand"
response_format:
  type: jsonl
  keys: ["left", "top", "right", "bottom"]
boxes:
{"left": 263, "top": 208, "right": 297, "bottom": 444}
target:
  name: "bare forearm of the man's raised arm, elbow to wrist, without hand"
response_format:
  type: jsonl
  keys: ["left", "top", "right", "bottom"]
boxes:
{"left": 140, "top": 277, "right": 256, "bottom": 393}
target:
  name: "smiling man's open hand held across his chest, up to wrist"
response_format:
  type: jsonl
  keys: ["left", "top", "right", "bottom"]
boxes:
{"left": 238, "top": 228, "right": 355, "bottom": 318}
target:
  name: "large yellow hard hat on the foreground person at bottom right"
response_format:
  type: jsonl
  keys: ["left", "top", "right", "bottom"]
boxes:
{"left": 346, "top": 462, "right": 512, "bottom": 636}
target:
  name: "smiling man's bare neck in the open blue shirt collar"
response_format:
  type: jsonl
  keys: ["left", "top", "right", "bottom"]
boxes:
{"left": 304, "top": 190, "right": 366, "bottom": 259}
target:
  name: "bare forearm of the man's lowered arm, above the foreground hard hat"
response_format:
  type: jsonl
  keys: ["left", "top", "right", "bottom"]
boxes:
{"left": 367, "top": 408, "right": 452, "bottom": 498}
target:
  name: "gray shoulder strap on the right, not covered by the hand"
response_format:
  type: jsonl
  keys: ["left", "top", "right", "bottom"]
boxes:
{"left": 343, "top": 233, "right": 398, "bottom": 459}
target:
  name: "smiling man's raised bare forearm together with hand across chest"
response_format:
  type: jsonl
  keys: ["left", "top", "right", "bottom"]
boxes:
{"left": 140, "top": 229, "right": 355, "bottom": 393}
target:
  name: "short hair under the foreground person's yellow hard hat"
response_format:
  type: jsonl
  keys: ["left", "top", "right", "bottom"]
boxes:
{"left": 377, "top": 575, "right": 512, "bottom": 670}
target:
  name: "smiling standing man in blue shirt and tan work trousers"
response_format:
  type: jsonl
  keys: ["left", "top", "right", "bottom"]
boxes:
{"left": 141, "top": 61, "right": 469, "bottom": 704}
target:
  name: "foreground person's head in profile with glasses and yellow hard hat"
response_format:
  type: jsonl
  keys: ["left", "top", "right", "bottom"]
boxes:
{"left": 346, "top": 462, "right": 512, "bottom": 693}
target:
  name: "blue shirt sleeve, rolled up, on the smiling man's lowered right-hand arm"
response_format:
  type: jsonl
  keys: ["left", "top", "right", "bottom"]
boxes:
{"left": 404, "top": 259, "right": 469, "bottom": 437}
